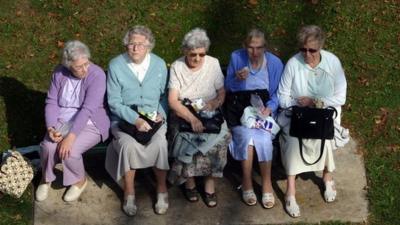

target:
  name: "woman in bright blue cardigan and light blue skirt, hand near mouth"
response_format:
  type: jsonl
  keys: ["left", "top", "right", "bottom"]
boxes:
{"left": 225, "top": 29, "right": 283, "bottom": 208}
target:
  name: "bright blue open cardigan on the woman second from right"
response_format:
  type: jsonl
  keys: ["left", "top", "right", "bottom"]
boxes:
{"left": 225, "top": 49, "right": 283, "bottom": 115}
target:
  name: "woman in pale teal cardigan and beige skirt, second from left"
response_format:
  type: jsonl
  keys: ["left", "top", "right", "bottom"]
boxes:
{"left": 106, "top": 26, "right": 169, "bottom": 216}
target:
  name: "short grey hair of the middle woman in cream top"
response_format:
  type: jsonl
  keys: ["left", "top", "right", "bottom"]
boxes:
{"left": 181, "top": 28, "right": 211, "bottom": 51}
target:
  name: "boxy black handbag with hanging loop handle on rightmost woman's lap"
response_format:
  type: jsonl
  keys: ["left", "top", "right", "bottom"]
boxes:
{"left": 289, "top": 106, "right": 337, "bottom": 165}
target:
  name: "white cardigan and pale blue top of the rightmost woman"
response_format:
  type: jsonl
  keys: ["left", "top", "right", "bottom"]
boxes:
{"left": 278, "top": 50, "right": 347, "bottom": 108}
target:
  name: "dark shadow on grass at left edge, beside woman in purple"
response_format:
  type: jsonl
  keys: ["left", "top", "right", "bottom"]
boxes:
{"left": 0, "top": 76, "right": 46, "bottom": 147}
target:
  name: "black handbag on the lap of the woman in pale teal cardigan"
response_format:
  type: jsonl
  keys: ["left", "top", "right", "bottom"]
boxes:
{"left": 118, "top": 105, "right": 163, "bottom": 145}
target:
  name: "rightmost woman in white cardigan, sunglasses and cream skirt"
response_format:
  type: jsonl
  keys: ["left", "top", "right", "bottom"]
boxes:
{"left": 278, "top": 25, "right": 347, "bottom": 217}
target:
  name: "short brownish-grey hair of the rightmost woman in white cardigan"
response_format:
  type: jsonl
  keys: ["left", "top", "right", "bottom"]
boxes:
{"left": 297, "top": 25, "right": 325, "bottom": 48}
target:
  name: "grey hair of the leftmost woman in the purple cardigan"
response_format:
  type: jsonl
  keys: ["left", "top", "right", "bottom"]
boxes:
{"left": 61, "top": 40, "right": 90, "bottom": 68}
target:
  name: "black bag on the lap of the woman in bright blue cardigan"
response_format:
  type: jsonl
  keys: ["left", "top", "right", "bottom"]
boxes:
{"left": 224, "top": 89, "right": 269, "bottom": 128}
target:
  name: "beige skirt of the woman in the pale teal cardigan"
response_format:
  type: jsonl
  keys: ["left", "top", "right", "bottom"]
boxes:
{"left": 106, "top": 124, "right": 169, "bottom": 183}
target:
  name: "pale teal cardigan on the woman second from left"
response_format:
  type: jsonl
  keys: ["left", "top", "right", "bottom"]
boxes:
{"left": 107, "top": 53, "right": 168, "bottom": 124}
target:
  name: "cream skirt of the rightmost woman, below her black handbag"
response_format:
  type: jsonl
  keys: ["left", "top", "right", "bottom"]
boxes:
{"left": 278, "top": 113, "right": 335, "bottom": 175}
